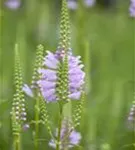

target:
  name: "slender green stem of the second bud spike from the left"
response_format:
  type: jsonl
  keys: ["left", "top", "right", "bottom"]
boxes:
{"left": 34, "top": 98, "right": 39, "bottom": 150}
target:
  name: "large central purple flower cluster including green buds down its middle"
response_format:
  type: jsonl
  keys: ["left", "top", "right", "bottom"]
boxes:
{"left": 37, "top": 51, "right": 85, "bottom": 102}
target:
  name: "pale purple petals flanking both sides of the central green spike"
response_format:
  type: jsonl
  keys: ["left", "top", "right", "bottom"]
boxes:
{"left": 37, "top": 50, "right": 85, "bottom": 102}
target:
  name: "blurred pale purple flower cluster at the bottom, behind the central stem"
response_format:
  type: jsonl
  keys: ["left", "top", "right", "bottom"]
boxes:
{"left": 49, "top": 119, "right": 82, "bottom": 149}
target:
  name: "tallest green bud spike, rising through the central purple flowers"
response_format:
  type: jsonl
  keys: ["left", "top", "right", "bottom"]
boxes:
{"left": 56, "top": 0, "right": 70, "bottom": 103}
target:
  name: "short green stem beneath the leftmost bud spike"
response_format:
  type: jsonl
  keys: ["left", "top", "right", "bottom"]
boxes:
{"left": 14, "top": 134, "right": 21, "bottom": 150}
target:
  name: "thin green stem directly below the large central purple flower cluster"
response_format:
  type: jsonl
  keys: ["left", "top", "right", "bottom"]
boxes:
{"left": 56, "top": 104, "right": 63, "bottom": 150}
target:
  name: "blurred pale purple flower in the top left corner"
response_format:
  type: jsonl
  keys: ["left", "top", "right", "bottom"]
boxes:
{"left": 5, "top": 0, "right": 21, "bottom": 10}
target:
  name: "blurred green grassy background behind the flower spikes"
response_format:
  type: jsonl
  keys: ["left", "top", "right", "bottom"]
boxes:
{"left": 0, "top": 0, "right": 135, "bottom": 150}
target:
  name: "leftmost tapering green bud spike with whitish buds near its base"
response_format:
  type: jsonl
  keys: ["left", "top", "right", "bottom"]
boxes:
{"left": 11, "top": 44, "right": 26, "bottom": 134}
